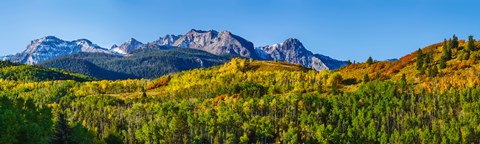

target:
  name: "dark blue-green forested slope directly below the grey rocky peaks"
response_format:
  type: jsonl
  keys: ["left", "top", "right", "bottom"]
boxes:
{"left": 39, "top": 48, "right": 231, "bottom": 79}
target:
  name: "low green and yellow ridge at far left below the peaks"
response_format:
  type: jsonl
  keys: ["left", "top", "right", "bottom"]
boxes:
{"left": 0, "top": 61, "right": 93, "bottom": 81}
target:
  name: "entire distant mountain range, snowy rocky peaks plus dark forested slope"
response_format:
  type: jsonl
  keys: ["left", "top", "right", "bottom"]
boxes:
{"left": 0, "top": 29, "right": 346, "bottom": 80}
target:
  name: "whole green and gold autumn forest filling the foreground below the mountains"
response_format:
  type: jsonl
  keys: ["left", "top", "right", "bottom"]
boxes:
{"left": 0, "top": 36, "right": 480, "bottom": 143}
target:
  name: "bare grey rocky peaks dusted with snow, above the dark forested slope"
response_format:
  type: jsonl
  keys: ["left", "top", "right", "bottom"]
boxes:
{"left": 0, "top": 29, "right": 345, "bottom": 70}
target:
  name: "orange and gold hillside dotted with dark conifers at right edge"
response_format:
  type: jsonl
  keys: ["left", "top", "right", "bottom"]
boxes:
{"left": 336, "top": 35, "right": 480, "bottom": 91}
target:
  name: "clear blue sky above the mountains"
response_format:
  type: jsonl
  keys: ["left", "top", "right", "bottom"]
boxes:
{"left": 0, "top": 0, "right": 480, "bottom": 61}
